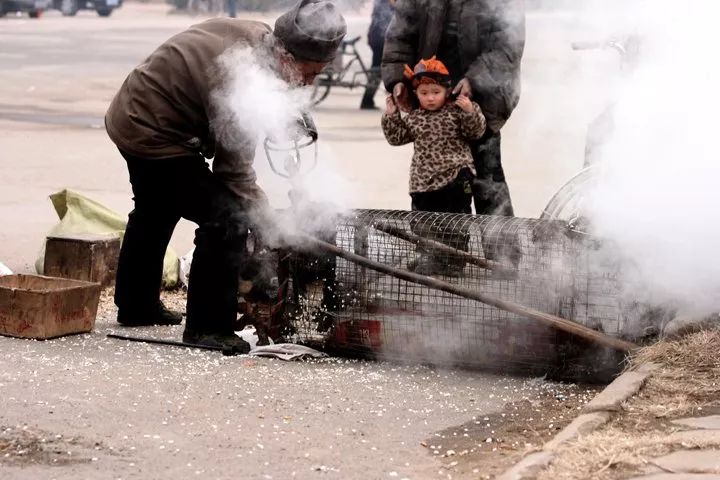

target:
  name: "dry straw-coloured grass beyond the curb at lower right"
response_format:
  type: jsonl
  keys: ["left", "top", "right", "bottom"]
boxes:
{"left": 538, "top": 328, "right": 720, "bottom": 480}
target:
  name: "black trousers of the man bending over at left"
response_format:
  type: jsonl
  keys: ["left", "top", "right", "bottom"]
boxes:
{"left": 115, "top": 151, "right": 248, "bottom": 335}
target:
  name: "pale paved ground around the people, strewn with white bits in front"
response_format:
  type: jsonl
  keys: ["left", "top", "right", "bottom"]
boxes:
{"left": 0, "top": 3, "right": 612, "bottom": 478}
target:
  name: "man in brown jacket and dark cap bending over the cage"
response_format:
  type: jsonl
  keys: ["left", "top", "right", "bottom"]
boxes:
{"left": 105, "top": 0, "right": 346, "bottom": 350}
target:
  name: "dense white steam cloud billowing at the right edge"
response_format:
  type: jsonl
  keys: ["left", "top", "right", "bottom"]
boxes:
{"left": 589, "top": 0, "right": 720, "bottom": 313}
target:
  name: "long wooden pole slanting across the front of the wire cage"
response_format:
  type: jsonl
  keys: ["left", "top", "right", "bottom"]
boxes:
{"left": 296, "top": 234, "right": 637, "bottom": 352}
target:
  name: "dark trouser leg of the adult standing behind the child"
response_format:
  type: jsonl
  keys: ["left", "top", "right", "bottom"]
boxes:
{"left": 471, "top": 128, "right": 522, "bottom": 266}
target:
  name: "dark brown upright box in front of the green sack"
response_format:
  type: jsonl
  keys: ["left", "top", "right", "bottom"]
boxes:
{"left": 44, "top": 234, "right": 120, "bottom": 287}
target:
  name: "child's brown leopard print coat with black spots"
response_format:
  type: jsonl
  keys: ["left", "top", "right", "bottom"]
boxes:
{"left": 382, "top": 102, "right": 485, "bottom": 193}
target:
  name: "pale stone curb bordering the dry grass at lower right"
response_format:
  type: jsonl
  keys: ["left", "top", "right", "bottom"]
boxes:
{"left": 496, "top": 363, "right": 659, "bottom": 480}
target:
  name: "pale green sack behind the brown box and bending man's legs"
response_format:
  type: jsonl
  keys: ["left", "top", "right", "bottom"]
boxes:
{"left": 35, "top": 189, "right": 180, "bottom": 288}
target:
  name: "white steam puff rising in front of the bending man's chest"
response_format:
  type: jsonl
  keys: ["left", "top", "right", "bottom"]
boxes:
{"left": 213, "top": 43, "right": 354, "bottom": 242}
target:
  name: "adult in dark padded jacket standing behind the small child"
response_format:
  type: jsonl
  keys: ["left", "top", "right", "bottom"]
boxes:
{"left": 382, "top": 0, "right": 525, "bottom": 215}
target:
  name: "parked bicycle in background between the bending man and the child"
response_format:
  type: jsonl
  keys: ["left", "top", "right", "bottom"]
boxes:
{"left": 310, "top": 36, "right": 380, "bottom": 105}
